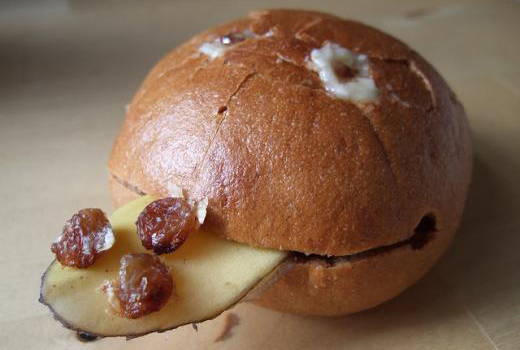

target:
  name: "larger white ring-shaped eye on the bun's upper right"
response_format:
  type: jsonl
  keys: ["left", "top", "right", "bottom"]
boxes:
{"left": 308, "top": 42, "right": 379, "bottom": 103}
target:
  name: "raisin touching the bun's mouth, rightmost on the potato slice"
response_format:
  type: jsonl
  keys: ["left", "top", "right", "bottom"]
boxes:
{"left": 136, "top": 197, "right": 197, "bottom": 254}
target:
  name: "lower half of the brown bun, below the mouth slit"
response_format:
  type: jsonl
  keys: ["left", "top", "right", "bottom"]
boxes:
{"left": 109, "top": 176, "right": 456, "bottom": 316}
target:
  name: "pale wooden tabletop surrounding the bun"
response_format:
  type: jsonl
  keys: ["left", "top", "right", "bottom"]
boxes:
{"left": 0, "top": 0, "right": 520, "bottom": 350}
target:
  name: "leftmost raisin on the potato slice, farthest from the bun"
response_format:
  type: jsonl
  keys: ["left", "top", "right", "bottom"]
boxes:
{"left": 51, "top": 208, "right": 114, "bottom": 268}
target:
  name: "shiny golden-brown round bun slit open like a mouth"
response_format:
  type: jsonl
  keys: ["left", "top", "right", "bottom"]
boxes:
{"left": 109, "top": 10, "right": 471, "bottom": 314}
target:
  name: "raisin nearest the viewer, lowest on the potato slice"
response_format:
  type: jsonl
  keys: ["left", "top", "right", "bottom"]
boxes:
{"left": 102, "top": 253, "right": 175, "bottom": 318}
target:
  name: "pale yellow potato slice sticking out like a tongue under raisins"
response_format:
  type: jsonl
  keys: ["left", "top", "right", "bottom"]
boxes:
{"left": 42, "top": 196, "right": 287, "bottom": 336}
